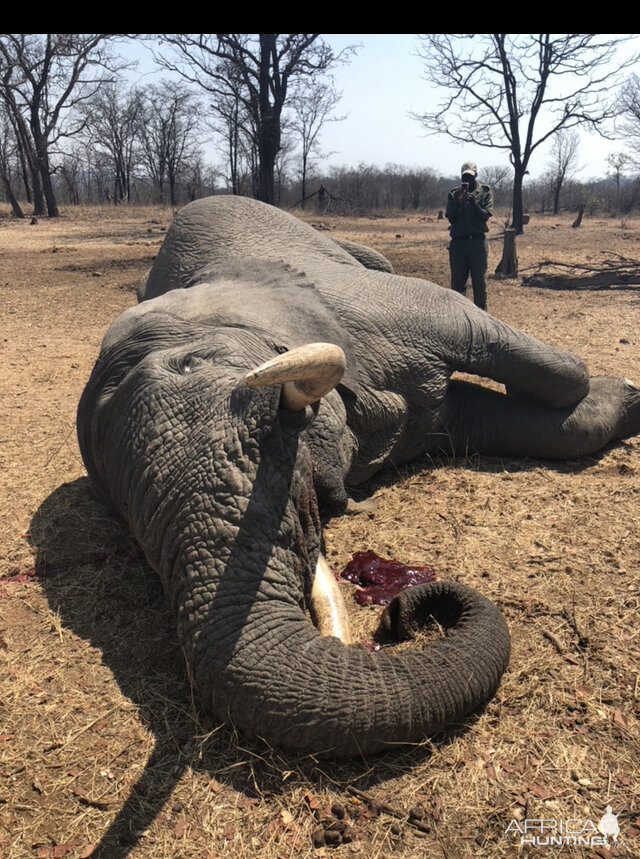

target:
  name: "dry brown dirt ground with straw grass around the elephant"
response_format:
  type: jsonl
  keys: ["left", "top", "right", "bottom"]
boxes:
{"left": 0, "top": 203, "right": 640, "bottom": 859}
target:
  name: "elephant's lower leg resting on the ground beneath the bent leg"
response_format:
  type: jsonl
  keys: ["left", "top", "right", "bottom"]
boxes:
{"left": 441, "top": 376, "right": 640, "bottom": 459}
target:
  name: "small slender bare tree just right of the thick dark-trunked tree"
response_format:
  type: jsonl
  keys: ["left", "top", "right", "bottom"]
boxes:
{"left": 291, "top": 78, "right": 346, "bottom": 208}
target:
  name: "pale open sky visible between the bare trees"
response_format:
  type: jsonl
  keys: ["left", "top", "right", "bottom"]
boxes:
{"left": 122, "top": 33, "right": 637, "bottom": 181}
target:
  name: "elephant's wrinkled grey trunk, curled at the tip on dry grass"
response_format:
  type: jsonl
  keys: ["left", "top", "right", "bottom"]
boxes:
{"left": 137, "top": 435, "right": 509, "bottom": 757}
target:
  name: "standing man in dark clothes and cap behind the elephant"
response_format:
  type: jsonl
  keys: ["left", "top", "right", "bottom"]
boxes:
{"left": 446, "top": 161, "right": 493, "bottom": 310}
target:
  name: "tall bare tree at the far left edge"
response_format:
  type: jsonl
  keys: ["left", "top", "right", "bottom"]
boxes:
{"left": 0, "top": 33, "right": 124, "bottom": 218}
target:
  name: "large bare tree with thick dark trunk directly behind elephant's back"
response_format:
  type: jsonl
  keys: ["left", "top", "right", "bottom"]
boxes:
{"left": 157, "top": 33, "right": 353, "bottom": 203}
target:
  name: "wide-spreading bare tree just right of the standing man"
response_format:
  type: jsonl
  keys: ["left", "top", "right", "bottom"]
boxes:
{"left": 416, "top": 33, "right": 637, "bottom": 233}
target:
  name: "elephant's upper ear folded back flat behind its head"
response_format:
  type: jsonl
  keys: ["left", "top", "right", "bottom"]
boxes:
{"left": 150, "top": 257, "right": 359, "bottom": 395}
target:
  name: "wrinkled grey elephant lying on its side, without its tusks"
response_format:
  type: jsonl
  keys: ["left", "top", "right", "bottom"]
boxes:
{"left": 78, "top": 197, "right": 640, "bottom": 755}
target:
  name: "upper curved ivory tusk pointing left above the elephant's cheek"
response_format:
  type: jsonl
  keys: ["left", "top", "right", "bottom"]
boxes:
{"left": 245, "top": 343, "right": 347, "bottom": 412}
